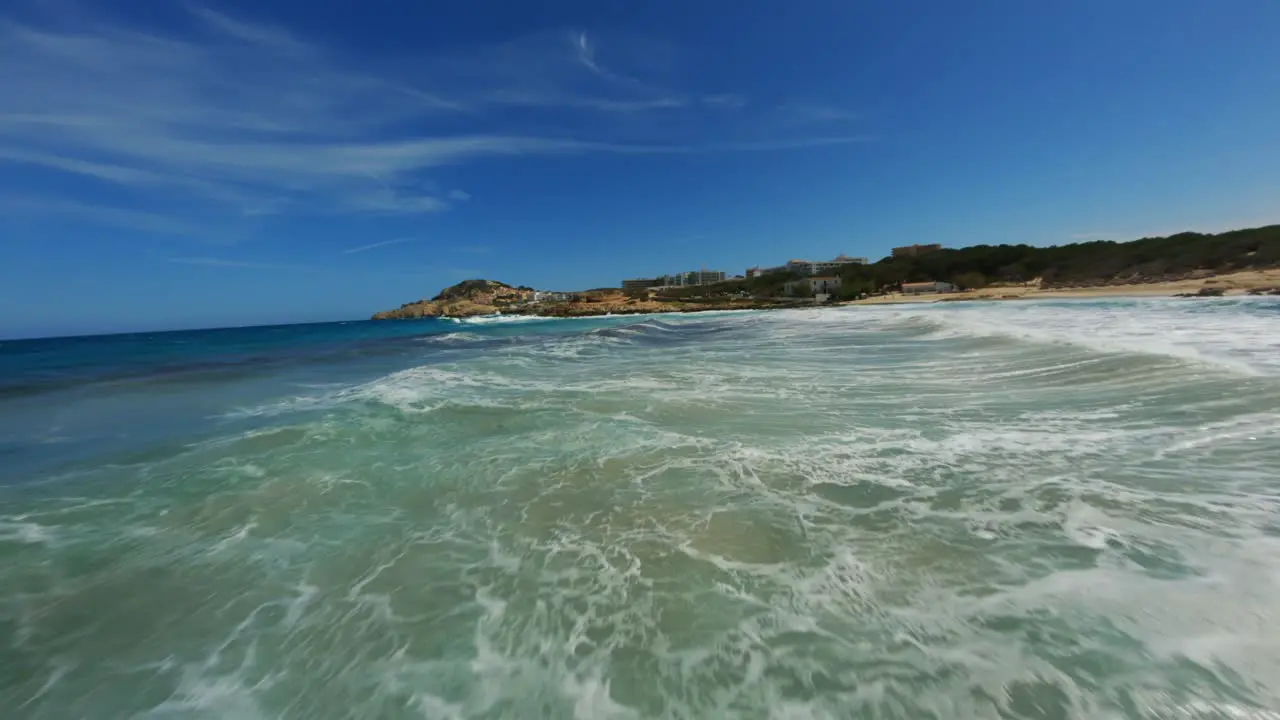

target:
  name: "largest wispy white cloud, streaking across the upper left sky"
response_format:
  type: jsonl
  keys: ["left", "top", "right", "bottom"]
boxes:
{"left": 0, "top": 5, "right": 859, "bottom": 233}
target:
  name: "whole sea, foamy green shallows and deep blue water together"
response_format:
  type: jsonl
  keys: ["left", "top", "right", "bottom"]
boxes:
{"left": 0, "top": 299, "right": 1280, "bottom": 720}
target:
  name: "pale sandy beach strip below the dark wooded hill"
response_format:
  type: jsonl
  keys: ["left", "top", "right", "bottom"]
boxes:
{"left": 849, "top": 270, "right": 1280, "bottom": 305}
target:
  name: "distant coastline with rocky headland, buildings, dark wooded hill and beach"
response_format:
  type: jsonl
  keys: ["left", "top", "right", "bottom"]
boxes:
{"left": 374, "top": 225, "right": 1280, "bottom": 320}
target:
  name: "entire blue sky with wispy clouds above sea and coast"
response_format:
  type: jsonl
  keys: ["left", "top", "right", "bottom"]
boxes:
{"left": 0, "top": 0, "right": 1280, "bottom": 337}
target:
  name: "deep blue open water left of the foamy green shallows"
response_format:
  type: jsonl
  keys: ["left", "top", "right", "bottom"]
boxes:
{"left": 0, "top": 319, "right": 618, "bottom": 484}
